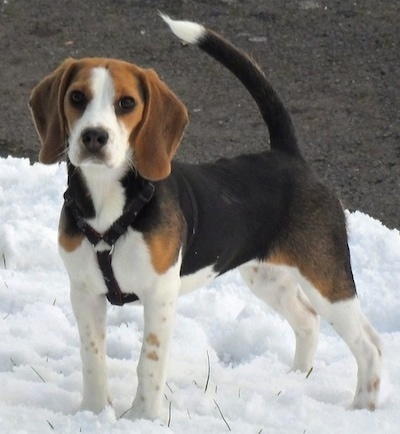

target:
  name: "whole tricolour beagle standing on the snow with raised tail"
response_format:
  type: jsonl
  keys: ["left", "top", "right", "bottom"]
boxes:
{"left": 30, "top": 16, "right": 381, "bottom": 419}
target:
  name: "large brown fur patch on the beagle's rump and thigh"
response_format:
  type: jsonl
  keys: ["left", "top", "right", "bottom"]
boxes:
{"left": 265, "top": 179, "right": 356, "bottom": 303}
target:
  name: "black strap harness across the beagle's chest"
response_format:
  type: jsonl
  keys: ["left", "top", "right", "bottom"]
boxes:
{"left": 64, "top": 180, "right": 155, "bottom": 306}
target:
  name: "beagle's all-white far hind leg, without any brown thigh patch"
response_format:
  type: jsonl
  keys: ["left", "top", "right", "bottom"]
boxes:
{"left": 239, "top": 262, "right": 319, "bottom": 372}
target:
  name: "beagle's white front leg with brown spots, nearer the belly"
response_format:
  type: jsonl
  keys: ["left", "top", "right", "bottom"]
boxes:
{"left": 124, "top": 277, "right": 179, "bottom": 420}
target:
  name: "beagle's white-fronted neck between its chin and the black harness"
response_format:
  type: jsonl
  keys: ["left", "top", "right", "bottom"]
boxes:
{"left": 68, "top": 162, "right": 141, "bottom": 233}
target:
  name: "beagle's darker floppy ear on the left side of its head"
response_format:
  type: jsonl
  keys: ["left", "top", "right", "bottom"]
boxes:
{"left": 29, "top": 59, "right": 76, "bottom": 164}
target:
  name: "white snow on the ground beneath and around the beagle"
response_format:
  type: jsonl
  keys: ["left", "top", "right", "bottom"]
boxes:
{"left": 0, "top": 157, "right": 400, "bottom": 434}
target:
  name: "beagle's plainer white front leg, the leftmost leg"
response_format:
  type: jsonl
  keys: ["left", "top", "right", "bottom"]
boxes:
{"left": 71, "top": 284, "right": 111, "bottom": 413}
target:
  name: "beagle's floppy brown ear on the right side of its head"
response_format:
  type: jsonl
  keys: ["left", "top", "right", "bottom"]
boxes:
{"left": 131, "top": 69, "right": 188, "bottom": 181}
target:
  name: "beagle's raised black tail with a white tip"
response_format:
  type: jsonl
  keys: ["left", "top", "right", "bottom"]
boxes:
{"left": 160, "top": 14, "right": 301, "bottom": 157}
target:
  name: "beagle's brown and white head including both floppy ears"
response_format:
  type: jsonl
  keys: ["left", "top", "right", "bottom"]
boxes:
{"left": 30, "top": 58, "right": 188, "bottom": 181}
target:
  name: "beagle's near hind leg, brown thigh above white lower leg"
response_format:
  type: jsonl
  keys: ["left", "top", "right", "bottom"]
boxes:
{"left": 268, "top": 244, "right": 381, "bottom": 410}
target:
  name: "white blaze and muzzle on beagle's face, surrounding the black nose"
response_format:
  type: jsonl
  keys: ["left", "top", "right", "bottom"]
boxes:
{"left": 68, "top": 67, "right": 129, "bottom": 169}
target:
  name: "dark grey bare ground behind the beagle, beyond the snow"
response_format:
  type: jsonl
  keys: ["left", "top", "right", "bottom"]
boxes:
{"left": 0, "top": 0, "right": 400, "bottom": 228}
